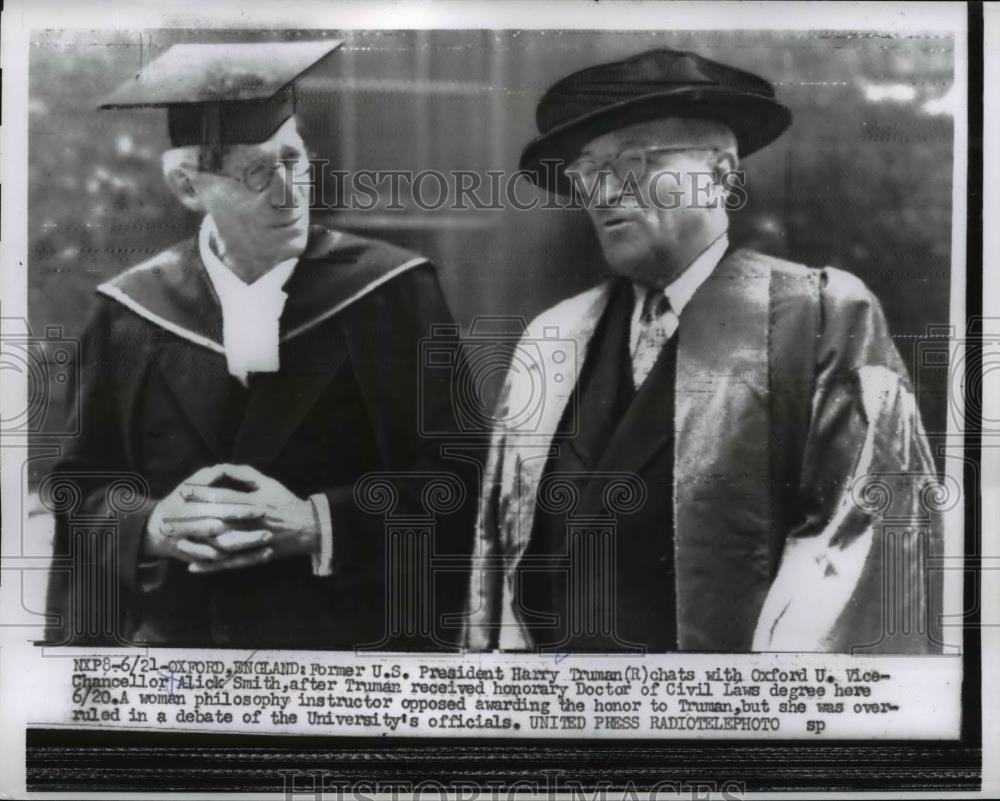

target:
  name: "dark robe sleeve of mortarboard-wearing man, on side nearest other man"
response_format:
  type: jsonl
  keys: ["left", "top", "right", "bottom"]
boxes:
{"left": 324, "top": 264, "right": 482, "bottom": 650}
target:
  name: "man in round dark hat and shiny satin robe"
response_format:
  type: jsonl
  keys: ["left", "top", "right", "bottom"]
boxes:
{"left": 465, "top": 50, "right": 940, "bottom": 652}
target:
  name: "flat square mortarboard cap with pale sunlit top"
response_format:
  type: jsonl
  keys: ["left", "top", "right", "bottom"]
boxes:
{"left": 101, "top": 39, "right": 343, "bottom": 147}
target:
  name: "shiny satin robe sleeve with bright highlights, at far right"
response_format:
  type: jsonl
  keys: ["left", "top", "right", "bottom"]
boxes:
{"left": 753, "top": 269, "right": 942, "bottom": 654}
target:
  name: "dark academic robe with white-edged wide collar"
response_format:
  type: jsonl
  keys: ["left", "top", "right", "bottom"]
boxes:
{"left": 42, "top": 226, "right": 475, "bottom": 649}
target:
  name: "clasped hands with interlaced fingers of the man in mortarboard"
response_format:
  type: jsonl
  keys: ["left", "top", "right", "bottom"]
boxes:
{"left": 143, "top": 464, "right": 319, "bottom": 573}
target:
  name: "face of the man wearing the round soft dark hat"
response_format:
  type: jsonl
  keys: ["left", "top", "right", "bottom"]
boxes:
{"left": 567, "top": 120, "right": 725, "bottom": 285}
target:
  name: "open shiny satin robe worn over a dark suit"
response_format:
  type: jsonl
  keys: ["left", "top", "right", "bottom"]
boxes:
{"left": 464, "top": 250, "right": 942, "bottom": 653}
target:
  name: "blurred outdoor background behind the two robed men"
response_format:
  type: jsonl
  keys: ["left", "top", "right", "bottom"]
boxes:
{"left": 27, "top": 30, "right": 964, "bottom": 466}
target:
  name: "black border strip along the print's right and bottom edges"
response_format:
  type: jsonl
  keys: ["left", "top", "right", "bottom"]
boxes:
{"left": 0, "top": 2, "right": 986, "bottom": 801}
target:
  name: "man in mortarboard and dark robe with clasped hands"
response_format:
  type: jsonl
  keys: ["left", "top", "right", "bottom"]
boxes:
{"left": 47, "top": 41, "right": 475, "bottom": 648}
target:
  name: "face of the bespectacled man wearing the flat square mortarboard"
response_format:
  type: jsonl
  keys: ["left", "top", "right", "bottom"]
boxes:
{"left": 193, "top": 117, "right": 309, "bottom": 264}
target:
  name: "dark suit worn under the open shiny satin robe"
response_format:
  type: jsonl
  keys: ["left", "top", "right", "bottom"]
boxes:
{"left": 519, "top": 279, "right": 677, "bottom": 653}
